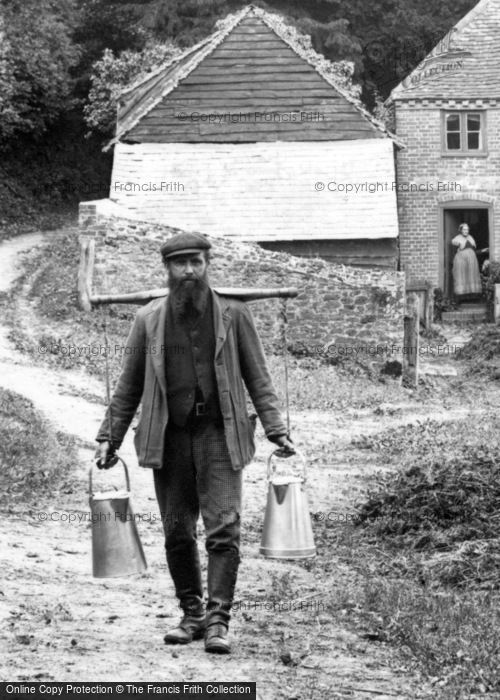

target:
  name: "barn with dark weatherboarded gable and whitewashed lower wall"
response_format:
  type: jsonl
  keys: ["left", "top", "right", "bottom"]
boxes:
{"left": 81, "top": 5, "right": 398, "bottom": 269}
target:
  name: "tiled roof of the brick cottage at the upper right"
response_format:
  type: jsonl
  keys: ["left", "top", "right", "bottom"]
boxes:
{"left": 389, "top": 0, "right": 500, "bottom": 101}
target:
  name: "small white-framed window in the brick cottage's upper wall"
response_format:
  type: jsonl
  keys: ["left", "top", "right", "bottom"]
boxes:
{"left": 443, "top": 112, "right": 486, "bottom": 155}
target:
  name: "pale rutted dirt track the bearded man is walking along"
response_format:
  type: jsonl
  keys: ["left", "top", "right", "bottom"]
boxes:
{"left": 0, "top": 234, "right": 436, "bottom": 700}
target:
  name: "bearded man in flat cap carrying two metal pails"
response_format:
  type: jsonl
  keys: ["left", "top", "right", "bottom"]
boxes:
{"left": 96, "top": 233, "right": 293, "bottom": 653}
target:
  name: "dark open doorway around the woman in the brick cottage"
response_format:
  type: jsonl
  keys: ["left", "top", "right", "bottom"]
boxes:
{"left": 443, "top": 207, "right": 490, "bottom": 298}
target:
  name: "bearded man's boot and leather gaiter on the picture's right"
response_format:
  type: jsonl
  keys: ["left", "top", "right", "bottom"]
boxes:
{"left": 205, "top": 550, "right": 240, "bottom": 654}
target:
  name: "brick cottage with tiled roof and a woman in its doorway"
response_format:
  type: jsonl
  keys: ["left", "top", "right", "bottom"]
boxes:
{"left": 388, "top": 0, "right": 500, "bottom": 308}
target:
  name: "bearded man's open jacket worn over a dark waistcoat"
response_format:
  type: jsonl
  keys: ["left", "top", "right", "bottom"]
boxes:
{"left": 97, "top": 291, "right": 287, "bottom": 470}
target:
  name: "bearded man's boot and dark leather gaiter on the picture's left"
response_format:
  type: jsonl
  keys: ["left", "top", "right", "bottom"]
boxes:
{"left": 164, "top": 543, "right": 206, "bottom": 644}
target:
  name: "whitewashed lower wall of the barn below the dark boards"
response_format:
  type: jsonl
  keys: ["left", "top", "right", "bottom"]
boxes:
{"left": 110, "top": 138, "right": 398, "bottom": 241}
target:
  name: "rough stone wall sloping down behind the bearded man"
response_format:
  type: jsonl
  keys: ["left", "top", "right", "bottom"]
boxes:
{"left": 80, "top": 203, "right": 404, "bottom": 366}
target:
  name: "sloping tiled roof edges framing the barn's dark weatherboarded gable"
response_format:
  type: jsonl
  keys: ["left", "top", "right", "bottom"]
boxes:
{"left": 104, "top": 5, "right": 401, "bottom": 150}
